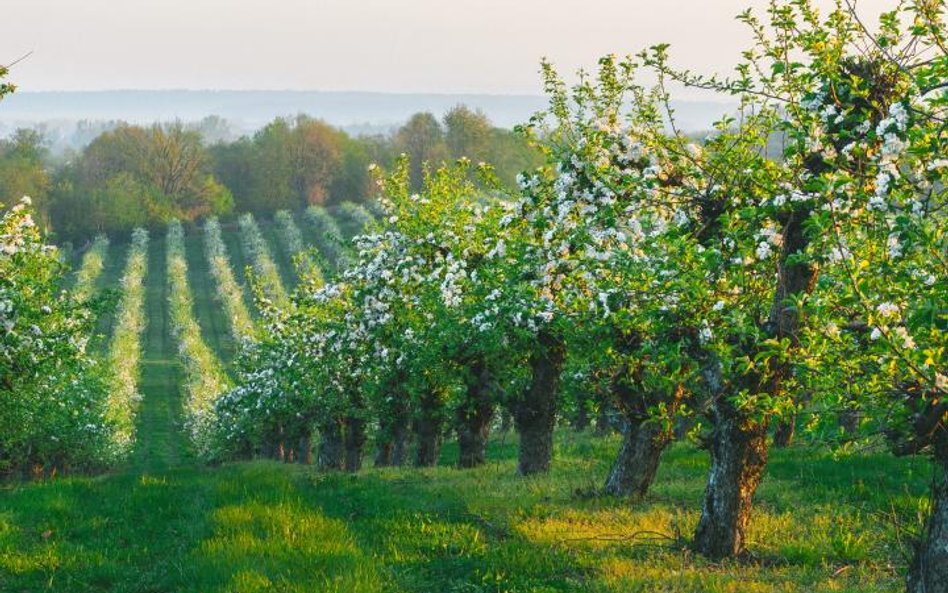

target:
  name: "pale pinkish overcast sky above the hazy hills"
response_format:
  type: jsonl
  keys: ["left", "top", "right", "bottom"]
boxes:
{"left": 0, "top": 0, "right": 894, "bottom": 94}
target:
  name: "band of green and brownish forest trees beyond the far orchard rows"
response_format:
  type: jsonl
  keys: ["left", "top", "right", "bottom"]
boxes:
{"left": 0, "top": 105, "right": 541, "bottom": 242}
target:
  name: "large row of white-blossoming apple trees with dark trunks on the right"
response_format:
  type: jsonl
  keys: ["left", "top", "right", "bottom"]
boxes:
{"left": 213, "top": 1, "right": 948, "bottom": 591}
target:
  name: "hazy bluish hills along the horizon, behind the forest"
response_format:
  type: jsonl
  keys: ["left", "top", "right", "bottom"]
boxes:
{"left": 0, "top": 90, "right": 731, "bottom": 150}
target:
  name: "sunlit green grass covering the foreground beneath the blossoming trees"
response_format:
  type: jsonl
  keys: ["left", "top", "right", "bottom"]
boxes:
{"left": 0, "top": 431, "right": 930, "bottom": 593}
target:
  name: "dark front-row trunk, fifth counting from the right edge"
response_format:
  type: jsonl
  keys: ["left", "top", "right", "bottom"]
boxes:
{"left": 455, "top": 357, "right": 494, "bottom": 468}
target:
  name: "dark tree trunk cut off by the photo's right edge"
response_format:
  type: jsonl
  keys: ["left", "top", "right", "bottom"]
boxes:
{"left": 907, "top": 425, "right": 948, "bottom": 593}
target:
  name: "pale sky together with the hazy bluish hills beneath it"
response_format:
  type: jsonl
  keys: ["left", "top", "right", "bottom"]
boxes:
{"left": 0, "top": 0, "right": 887, "bottom": 153}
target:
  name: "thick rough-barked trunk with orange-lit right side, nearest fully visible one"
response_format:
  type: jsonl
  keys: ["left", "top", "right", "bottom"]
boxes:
{"left": 694, "top": 398, "right": 767, "bottom": 560}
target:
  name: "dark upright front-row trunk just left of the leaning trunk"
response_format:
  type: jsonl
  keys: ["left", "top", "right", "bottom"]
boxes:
{"left": 513, "top": 330, "right": 566, "bottom": 476}
